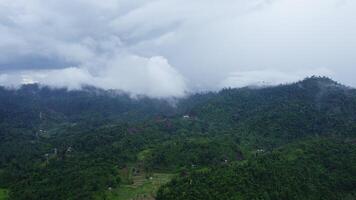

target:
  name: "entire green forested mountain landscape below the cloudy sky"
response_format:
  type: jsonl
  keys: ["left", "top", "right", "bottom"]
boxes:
{"left": 0, "top": 77, "right": 356, "bottom": 200}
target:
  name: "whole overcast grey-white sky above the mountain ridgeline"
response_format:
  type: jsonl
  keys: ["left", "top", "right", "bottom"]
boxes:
{"left": 0, "top": 0, "right": 356, "bottom": 98}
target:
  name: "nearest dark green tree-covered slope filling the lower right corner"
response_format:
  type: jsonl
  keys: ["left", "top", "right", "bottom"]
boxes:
{"left": 157, "top": 140, "right": 356, "bottom": 200}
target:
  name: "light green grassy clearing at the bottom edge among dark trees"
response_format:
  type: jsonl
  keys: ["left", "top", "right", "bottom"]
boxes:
{"left": 107, "top": 173, "right": 174, "bottom": 200}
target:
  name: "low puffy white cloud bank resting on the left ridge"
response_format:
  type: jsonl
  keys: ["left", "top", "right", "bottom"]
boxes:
{"left": 0, "top": 55, "right": 186, "bottom": 98}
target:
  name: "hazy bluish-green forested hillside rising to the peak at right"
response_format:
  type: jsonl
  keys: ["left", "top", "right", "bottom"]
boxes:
{"left": 184, "top": 77, "right": 356, "bottom": 148}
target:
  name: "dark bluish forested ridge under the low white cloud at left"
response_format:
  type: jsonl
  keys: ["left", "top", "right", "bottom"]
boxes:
{"left": 0, "top": 84, "right": 178, "bottom": 127}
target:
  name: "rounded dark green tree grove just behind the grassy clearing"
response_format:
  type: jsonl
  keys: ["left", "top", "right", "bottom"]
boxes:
{"left": 146, "top": 137, "right": 243, "bottom": 170}
